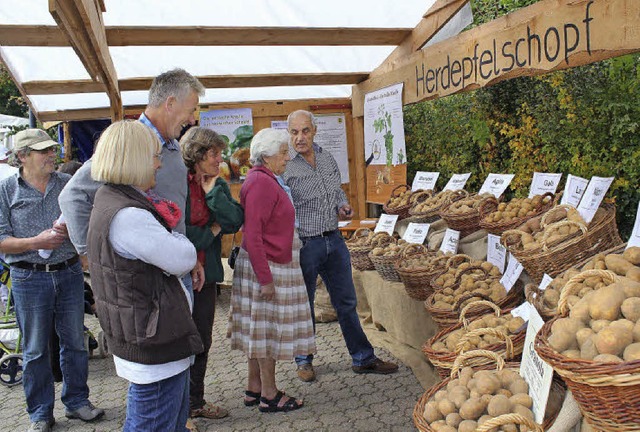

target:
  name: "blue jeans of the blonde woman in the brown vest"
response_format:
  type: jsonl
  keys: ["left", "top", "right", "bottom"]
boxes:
{"left": 122, "top": 369, "right": 189, "bottom": 432}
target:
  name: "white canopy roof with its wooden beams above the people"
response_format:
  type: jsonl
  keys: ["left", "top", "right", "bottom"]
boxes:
{"left": 0, "top": 0, "right": 476, "bottom": 121}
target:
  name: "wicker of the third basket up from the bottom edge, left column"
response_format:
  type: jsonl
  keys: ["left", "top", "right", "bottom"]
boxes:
{"left": 424, "top": 266, "right": 524, "bottom": 330}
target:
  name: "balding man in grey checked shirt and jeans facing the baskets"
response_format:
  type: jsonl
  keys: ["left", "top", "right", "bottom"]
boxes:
{"left": 282, "top": 110, "right": 398, "bottom": 382}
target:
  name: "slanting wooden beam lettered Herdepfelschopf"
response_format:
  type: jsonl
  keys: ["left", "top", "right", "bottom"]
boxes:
{"left": 352, "top": 0, "right": 640, "bottom": 116}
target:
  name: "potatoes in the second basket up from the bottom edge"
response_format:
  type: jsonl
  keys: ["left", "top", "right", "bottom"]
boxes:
{"left": 431, "top": 314, "right": 525, "bottom": 352}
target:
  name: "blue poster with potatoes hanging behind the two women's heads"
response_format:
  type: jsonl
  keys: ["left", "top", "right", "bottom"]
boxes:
{"left": 200, "top": 108, "right": 253, "bottom": 182}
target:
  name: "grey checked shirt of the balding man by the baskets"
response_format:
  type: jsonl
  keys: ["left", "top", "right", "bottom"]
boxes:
{"left": 282, "top": 143, "right": 349, "bottom": 237}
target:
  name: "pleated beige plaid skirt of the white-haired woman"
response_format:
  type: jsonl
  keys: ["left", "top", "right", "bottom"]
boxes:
{"left": 229, "top": 234, "right": 316, "bottom": 360}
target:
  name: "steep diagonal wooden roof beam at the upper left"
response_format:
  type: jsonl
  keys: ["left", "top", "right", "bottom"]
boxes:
{"left": 49, "top": 0, "right": 123, "bottom": 120}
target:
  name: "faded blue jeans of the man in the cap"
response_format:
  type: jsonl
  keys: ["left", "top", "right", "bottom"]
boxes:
{"left": 11, "top": 263, "right": 89, "bottom": 422}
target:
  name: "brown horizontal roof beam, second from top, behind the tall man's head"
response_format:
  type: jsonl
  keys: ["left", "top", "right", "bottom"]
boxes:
{"left": 22, "top": 72, "right": 369, "bottom": 95}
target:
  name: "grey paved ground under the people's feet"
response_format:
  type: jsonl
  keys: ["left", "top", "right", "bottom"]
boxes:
{"left": 0, "top": 289, "right": 423, "bottom": 432}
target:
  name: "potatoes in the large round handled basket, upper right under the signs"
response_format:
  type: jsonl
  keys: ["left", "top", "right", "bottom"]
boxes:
{"left": 501, "top": 207, "right": 588, "bottom": 251}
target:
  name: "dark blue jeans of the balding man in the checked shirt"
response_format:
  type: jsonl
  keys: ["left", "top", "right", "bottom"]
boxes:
{"left": 296, "top": 230, "right": 376, "bottom": 366}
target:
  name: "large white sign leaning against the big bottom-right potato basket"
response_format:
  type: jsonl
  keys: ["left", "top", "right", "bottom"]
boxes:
{"left": 520, "top": 308, "right": 553, "bottom": 424}
